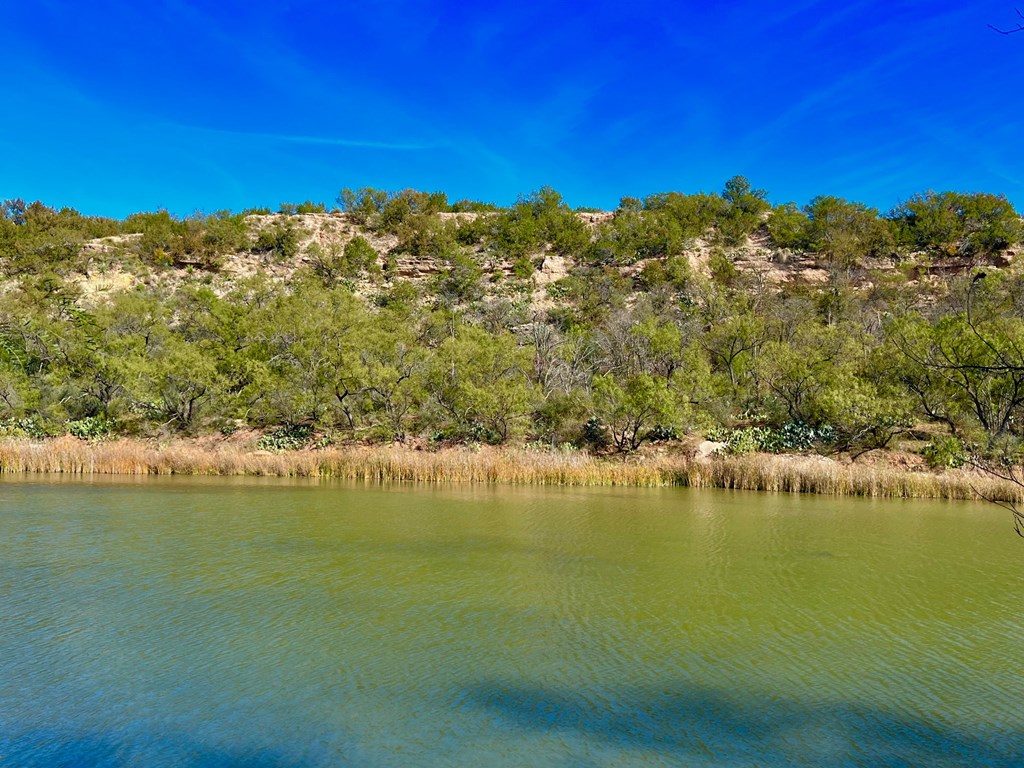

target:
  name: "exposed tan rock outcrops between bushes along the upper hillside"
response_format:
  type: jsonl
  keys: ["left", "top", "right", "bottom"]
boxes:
{"left": 69, "top": 211, "right": 1020, "bottom": 311}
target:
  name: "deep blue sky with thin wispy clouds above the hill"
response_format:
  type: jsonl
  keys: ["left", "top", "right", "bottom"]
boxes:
{"left": 0, "top": 0, "right": 1024, "bottom": 216}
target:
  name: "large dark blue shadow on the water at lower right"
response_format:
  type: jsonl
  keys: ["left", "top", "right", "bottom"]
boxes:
{"left": 461, "top": 684, "right": 1024, "bottom": 768}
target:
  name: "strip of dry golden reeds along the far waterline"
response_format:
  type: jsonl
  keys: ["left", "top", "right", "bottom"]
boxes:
{"left": 0, "top": 437, "right": 1022, "bottom": 502}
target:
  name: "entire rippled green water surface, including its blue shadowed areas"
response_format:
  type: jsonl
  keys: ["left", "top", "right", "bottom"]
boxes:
{"left": 0, "top": 478, "right": 1024, "bottom": 768}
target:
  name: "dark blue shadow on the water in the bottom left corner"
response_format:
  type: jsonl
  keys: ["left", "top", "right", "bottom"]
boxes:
{"left": 0, "top": 729, "right": 364, "bottom": 768}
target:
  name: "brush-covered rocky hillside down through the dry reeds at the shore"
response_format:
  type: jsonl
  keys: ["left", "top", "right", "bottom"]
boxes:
{"left": 0, "top": 182, "right": 1024, "bottom": 496}
